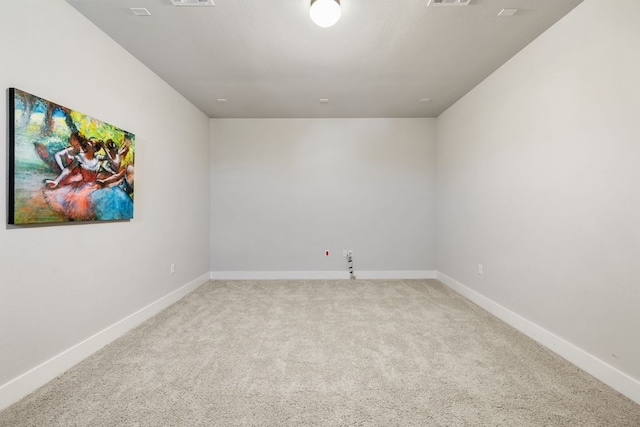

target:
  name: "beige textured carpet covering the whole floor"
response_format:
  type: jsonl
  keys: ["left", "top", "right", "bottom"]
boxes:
{"left": 0, "top": 280, "right": 640, "bottom": 427}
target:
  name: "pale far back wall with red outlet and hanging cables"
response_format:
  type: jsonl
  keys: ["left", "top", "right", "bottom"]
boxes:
{"left": 211, "top": 119, "right": 435, "bottom": 277}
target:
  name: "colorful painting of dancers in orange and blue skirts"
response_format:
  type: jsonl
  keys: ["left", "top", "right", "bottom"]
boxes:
{"left": 8, "top": 88, "right": 135, "bottom": 225}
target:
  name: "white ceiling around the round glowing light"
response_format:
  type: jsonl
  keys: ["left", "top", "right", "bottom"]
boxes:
{"left": 66, "top": 0, "right": 582, "bottom": 118}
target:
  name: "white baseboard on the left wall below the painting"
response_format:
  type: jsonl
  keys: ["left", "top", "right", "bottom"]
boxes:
{"left": 0, "top": 273, "right": 209, "bottom": 410}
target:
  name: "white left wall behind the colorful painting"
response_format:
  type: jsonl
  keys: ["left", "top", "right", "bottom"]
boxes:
{"left": 0, "top": 0, "right": 209, "bottom": 403}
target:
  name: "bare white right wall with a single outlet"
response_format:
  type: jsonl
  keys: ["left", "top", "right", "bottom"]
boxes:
{"left": 436, "top": 0, "right": 640, "bottom": 392}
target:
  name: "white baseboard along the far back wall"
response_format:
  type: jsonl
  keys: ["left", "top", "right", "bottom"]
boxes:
{"left": 211, "top": 270, "right": 436, "bottom": 280}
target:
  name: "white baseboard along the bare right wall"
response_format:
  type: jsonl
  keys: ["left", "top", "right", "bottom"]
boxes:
{"left": 436, "top": 272, "right": 640, "bottom": 404}
